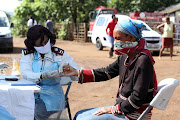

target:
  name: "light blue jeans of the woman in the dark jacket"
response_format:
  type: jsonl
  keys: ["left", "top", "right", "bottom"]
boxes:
{"left": 73, "top": 107, "right": 129, "bottom": 120}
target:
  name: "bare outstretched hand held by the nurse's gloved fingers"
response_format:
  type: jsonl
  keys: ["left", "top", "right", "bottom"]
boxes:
{"left": 61, "top": 65, "right": 78, "bottom": 77}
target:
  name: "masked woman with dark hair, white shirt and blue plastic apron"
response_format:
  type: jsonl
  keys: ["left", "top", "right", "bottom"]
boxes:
{"left": 20, "top": 25, "right": 79, "bottom": 120}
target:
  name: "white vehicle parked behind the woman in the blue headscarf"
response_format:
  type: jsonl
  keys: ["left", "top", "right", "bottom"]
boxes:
{"left": 91, "top": 14, "right": 162, "bottom": 53}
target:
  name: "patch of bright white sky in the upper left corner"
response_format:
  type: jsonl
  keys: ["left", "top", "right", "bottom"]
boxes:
{"left": 0, "top": 0, "right": 20, "bottom": 12}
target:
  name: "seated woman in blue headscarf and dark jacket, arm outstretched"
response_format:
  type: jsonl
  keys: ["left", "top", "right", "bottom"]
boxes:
{"left": 63, "top": 18, "right": 157, "bottom": 120}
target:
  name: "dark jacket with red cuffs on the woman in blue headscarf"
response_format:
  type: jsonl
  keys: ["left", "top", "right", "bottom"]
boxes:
{"left": 79, "top": 53, "right": 154, "bottom": 120}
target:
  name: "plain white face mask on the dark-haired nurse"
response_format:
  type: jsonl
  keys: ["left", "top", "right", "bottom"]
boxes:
{"left": 34, "top": 39, "right": 51, "bottom": 54}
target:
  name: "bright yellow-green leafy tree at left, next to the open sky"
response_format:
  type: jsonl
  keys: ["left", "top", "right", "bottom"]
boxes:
{"left": 13, "top": 0, "right": 46, "bottom": 36}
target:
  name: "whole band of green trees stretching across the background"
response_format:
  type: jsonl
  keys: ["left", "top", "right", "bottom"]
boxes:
{"left": 13, "top": 0, "right": 180, "bottom": 36}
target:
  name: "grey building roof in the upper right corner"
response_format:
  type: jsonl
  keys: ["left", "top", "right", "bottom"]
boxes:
{"left": 160, "top": 3, "right": 180, "bottom": 13}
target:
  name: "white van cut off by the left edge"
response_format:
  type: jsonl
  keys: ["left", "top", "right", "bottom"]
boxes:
{"left": 0, "top": 11, "right": 13, "bottom": 52}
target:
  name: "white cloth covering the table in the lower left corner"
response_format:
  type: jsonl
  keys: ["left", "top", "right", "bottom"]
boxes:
{"left": 0, "top": 76, "right": 40, "bottom": 120}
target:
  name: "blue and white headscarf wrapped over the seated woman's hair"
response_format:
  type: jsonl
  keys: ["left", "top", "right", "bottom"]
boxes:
{"left": 114, "top": 18, "right": 146, "bottom": 40}
